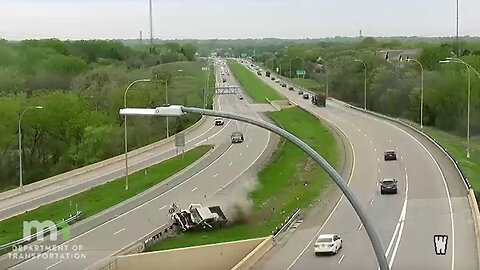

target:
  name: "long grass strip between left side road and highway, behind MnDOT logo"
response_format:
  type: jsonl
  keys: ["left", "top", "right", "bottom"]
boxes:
{"left": 0, "top": 145, "right": 211, "bottom": 245}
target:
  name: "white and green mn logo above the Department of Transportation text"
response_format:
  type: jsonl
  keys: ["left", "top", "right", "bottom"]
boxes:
{"left": 23, "top": 220, "right": 70, "bottom": 241}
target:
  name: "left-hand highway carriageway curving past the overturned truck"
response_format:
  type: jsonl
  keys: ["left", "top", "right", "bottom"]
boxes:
{"left": 5, "top": 61, "right": 277, "bottom": 269}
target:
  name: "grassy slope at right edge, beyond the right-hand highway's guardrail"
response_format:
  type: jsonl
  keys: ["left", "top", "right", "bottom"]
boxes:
{"left": 424, "top": 127, "right": 480, "bottom": 193}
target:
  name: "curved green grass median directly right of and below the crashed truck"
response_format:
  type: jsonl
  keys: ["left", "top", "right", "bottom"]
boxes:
{"left": 150, "top": 108, "right": 339, "bottom": 250}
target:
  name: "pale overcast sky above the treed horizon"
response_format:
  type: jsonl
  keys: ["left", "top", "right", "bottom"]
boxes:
{"left": 0, "top": 0, "right": 480, "bottom": 40}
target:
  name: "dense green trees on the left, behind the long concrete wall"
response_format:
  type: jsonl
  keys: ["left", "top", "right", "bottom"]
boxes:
{"left": 0, "top": 39, "right": 213, "bottom": 190}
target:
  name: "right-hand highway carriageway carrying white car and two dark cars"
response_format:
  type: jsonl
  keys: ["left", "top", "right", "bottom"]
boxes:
{"left": 246, "top": 61, "right": 478, "bottom": 270}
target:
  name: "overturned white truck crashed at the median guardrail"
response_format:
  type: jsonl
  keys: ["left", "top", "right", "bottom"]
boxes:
{"left": 170, "top": 204, "right": 228, "bottom": 231}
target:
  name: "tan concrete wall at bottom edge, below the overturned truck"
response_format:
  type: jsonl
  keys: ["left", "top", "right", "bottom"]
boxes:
{"left": 115, "top": 237, "right": 271, "bottom": 270}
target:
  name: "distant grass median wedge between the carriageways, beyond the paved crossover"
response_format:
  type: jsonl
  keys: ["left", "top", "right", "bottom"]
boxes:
{"left": 228, "top": 60, "right": 283, "bottom": 103}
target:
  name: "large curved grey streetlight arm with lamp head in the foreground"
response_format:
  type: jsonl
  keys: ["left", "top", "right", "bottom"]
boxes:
{"left": 120, "top": 105, "right": 389, "bottom": 270}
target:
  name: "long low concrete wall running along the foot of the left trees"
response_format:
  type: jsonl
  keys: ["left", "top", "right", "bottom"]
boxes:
{"left": 0, "top": 116, "right": 206, "bottom": 200}
